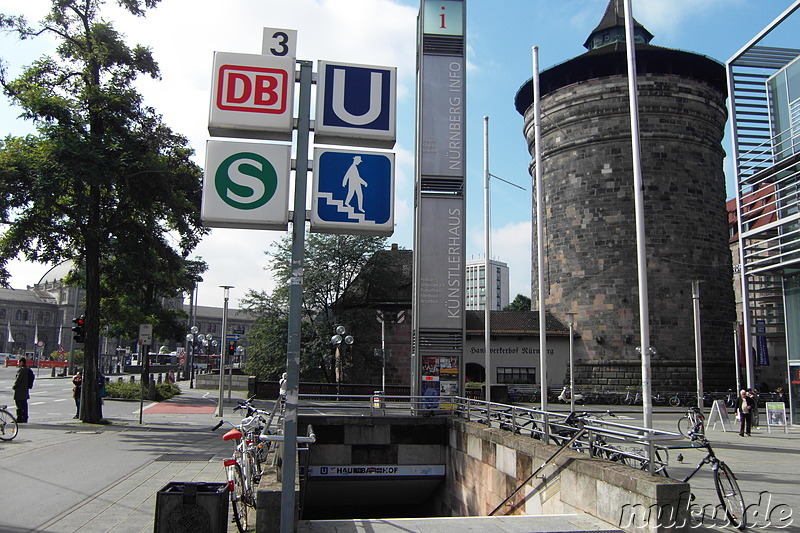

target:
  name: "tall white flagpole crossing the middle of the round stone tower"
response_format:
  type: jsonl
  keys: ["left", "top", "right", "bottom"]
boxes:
{"left": 624, "top": 0, "right": 653, "bottom": 432}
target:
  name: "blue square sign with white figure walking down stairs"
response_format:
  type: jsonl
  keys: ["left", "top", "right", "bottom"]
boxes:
{"left": 311, "top": 148, "right": 394, "bottom": 236}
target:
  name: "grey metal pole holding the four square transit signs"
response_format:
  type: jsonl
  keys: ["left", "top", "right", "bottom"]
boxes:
{"left": 280, "top": 61, "right": 312, "bottom": 533}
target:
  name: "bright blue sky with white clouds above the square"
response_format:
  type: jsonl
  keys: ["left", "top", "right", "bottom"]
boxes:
{"left": 0, "top": 0, "right": 797, "bottom": 307}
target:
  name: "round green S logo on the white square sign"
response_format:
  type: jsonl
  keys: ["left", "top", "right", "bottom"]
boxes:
{"left": 214, "top": 152, "right": 278, "bottom": 210}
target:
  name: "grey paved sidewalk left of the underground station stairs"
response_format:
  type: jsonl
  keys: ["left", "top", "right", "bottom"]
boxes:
{"left": 0, "top": 376, "right": 244, "bottom": 533}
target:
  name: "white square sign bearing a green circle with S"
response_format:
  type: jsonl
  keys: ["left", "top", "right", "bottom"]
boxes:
{"left": 200, "top": 141, "right": 291, "bottom": 230}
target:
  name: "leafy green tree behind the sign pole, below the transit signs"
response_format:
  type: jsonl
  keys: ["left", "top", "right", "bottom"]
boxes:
{"left": 247, "top": 233, "right": 386, "bottom": 382}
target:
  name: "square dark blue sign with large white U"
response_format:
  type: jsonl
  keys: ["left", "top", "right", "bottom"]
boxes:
{"left": 314, "top": 61, "right": 397, "bottom": 148}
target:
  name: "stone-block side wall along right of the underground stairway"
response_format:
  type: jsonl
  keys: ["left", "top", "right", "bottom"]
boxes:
{"left": 439, "top": 418, "right": 689, "bottom": 533}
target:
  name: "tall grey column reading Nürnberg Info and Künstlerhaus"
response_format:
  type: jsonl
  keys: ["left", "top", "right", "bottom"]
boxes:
{"left": 411, "top": 0, "right": 466, "bottom": 411}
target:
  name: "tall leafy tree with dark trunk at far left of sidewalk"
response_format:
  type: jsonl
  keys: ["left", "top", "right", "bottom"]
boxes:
{"left": 0, "top": 0, "right": 205, "bottom": 423}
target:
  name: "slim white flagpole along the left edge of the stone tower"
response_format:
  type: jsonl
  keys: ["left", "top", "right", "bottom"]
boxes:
{"left": 533, "top": 46, "right": 547, "bottom": 411}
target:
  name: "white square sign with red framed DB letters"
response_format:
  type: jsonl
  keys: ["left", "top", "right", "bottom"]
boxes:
{"left": 208, "top": 52, "right": 295, "bottom": 140}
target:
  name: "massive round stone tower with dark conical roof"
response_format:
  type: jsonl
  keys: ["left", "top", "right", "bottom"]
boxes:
{"left": 515, "top": 0, "right": 735, "bottom": 392}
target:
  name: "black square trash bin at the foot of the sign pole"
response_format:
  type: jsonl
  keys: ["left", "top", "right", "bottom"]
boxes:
{"left": 154, "top": 481, "right": 229, "bottom": 533}
